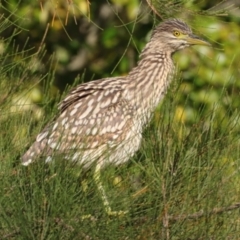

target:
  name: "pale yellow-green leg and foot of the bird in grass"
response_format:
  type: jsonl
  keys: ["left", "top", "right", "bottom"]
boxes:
{"left": 94, "top": 163, "right": 127, "bottom": 216}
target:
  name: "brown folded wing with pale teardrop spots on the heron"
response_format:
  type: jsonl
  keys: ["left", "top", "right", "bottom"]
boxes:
{"left": 36, "top": 78, "right": 133, "bottom": 152}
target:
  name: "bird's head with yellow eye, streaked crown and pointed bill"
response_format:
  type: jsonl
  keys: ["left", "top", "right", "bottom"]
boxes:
{"left": 151, "top": 19, "right": 210, "bottom": 53}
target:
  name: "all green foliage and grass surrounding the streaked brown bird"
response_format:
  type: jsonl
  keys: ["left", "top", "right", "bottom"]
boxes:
{"left": 0, "top": 0, "right": 240, "bottom": 237}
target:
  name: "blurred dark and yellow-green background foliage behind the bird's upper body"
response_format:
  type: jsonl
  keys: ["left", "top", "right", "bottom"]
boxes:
{"left": 0, "top": 0, "right": 240, "bottom": 144}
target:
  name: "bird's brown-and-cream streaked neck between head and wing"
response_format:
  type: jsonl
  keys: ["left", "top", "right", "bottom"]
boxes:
{"left": 126, "top": 48, "right": 174, "bottom": 123}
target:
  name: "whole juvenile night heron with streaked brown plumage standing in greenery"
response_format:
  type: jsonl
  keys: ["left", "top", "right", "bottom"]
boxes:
{"left": 22, "top": 19, "right": 209, "bottom": 214}
